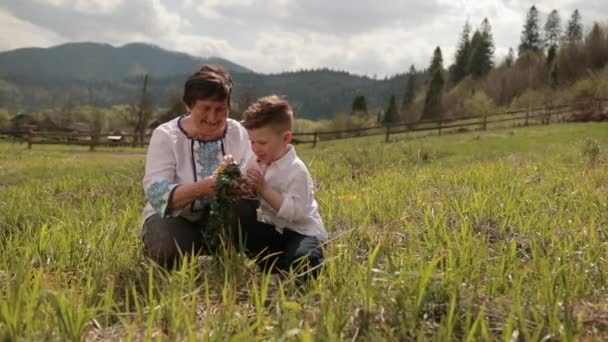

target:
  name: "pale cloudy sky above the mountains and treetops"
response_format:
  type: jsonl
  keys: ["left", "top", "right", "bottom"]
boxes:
{"left": 0, "top": 0, "right": 608, "bottom": 77}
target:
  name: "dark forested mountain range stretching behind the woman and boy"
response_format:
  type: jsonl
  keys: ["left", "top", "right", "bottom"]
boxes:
{"left": 0, "top": 43, "right": 424, "bottom": 119}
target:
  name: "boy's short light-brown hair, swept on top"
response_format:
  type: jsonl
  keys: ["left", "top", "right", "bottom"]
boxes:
{"left": 241, "top": 95, "right": 293, "bottom": 132}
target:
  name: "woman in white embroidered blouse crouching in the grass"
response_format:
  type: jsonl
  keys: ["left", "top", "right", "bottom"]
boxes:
{"left": 141, "top": 66, "right": 251, "bottom": 267}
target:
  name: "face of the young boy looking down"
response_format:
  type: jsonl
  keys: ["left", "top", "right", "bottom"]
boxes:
{"left": 247, "top": 125, "right": 291, "bottom": 165}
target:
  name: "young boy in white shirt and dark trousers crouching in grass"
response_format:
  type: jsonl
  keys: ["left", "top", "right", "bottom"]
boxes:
{"left": 240, "top": 95, "right": 327, "bottom": 276}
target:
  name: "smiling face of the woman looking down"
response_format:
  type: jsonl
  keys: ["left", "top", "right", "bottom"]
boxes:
{"left": 188, "top": 99, "right": 229, "bottom": 137}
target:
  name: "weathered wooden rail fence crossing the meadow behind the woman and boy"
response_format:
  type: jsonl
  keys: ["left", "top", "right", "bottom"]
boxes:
{"left": 0, "top": 99, "right": 608, "bottom": 150}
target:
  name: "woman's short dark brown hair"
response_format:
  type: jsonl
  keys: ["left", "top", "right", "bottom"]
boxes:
{"left": 183, "top": 65, "right": 232, "bottom": 107}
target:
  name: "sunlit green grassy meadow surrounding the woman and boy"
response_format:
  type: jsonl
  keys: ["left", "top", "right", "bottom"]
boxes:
{"left": 0, "top": 123, "right": 608, "bottom": 341}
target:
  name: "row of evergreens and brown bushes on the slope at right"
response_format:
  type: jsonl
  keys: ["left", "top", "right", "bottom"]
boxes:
{"left": 351, "top": 6, "right": 608, "bottom": 130}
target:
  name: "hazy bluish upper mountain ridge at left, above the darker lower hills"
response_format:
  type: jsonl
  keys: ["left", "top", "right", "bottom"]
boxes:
{"left": 0, "top": 43, "right": 251, "bottom": 81}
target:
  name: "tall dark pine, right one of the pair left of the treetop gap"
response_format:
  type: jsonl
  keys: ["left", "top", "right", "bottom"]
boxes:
{"left": 469, "top": 18, "right": 494, "bottom": 79}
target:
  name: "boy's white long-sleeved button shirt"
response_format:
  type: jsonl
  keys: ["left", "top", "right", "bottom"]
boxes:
{"left": 245, "top": 145, "right": 327, "bottom": 241}
